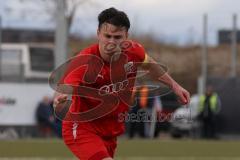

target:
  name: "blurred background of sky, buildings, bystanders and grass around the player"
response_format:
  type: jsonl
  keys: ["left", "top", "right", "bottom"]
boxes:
{"left": 0, "top": 0, "right": 240, "bottom": 160}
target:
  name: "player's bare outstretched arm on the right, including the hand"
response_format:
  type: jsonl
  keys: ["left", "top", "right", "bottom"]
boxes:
{"left": 143, "top": 54, "right": 190, "bottom": 104}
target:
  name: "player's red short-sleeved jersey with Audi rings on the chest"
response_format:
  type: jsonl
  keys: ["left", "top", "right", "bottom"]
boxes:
{"left": 63, "top": 41, "right": 145, "bottom": 137}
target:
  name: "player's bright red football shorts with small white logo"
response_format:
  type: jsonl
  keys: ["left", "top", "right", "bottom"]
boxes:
{"left": 62, "top": 123, "right": 117, "bottom": 160}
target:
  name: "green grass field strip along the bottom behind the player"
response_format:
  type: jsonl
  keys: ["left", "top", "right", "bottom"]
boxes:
{"left": 0, "top": 139, "right": 240, "bottom": 160}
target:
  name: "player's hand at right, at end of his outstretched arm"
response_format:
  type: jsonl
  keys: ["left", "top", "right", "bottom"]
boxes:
{"left": 173, "top": 83, "right": 190, "bottom": 105}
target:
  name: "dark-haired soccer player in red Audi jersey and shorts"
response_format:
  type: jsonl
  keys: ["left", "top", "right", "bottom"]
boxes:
{"left": 54, "top": 8, "right": 190, "bottom": 160}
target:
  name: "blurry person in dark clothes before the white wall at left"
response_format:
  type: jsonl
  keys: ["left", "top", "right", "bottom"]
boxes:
{"left": 36, "top": 96, "right": 56, "bottom": 137}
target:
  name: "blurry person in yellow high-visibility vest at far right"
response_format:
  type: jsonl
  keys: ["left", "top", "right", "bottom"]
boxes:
{"left": 198, "top": 85, "right": 221, "bottom": 138}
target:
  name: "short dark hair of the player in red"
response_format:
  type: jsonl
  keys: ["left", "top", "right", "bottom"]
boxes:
{"left": 98, "top": 7, "right": 130, "bottom": 31}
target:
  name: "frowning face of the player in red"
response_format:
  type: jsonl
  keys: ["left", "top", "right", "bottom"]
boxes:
{"left": 97, "top": 23, "right": 128, "bottom": 61}
